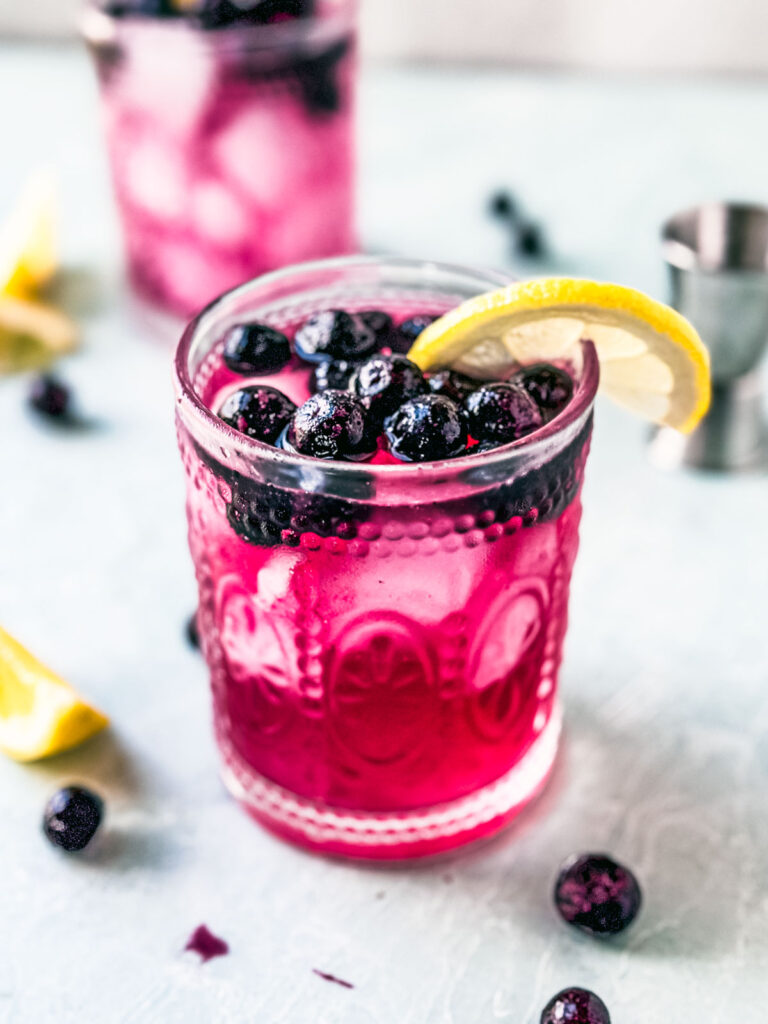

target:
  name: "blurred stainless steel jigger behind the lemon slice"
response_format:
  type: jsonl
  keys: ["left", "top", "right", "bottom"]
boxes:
{"left": 651, "top": 203, "right": 768, "bottom": 470}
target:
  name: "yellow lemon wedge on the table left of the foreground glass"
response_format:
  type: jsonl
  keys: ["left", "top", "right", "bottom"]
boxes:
{"left": 0, "top": 629, "right": 109, "bottom": 761}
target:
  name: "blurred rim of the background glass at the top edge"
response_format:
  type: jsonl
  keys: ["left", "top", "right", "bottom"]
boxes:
{"left": 80, "top": 0, "right": 357, "bottom": 51}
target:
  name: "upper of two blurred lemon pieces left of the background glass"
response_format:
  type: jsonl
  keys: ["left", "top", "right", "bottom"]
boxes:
{"left": 0, "top": 170, "right": 58, "bottom": 296}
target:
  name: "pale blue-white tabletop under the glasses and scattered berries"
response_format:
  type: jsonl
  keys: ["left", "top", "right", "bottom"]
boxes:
{"left": 0, "top": 47, "right": 768, "bottom": 1024}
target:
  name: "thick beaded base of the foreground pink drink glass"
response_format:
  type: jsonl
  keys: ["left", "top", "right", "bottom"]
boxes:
{"left": 217, "top": 705, "right": 562, "bottom": 860}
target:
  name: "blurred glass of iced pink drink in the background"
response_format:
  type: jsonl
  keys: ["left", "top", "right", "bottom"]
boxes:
{"left": 84, "top": 0, "right": 355, "bottom": 318}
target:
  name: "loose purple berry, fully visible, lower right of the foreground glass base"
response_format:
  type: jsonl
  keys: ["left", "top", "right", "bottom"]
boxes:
{"left": 554, "top": 853, "right": 642, "bottom": 936}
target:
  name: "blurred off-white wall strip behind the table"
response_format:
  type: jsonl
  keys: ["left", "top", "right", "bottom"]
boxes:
{"left": 0, "top": 0, "right": 768, "bottom": 72}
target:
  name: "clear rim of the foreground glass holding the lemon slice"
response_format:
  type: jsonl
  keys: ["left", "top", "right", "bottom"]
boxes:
{"left": 173, "top": 256, "right": 600, "bottom": 483}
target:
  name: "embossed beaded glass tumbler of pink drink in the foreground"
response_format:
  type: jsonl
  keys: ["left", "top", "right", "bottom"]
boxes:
{"left": 176, "top": 257, "right": 598, "bottom": 858}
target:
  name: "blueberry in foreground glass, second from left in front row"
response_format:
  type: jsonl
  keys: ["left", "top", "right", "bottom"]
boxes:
{"left": 286, "top": 389, "right": 375, "bottom": 459}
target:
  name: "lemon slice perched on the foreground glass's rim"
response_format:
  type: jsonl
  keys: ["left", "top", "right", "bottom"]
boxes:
{"left": 409, "top": 278, "right": 711, "bottom": 433}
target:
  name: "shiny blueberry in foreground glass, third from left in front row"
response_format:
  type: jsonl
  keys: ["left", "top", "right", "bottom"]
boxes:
{"left": 384, "top": 394, "right": 467, "bottom": 462}
